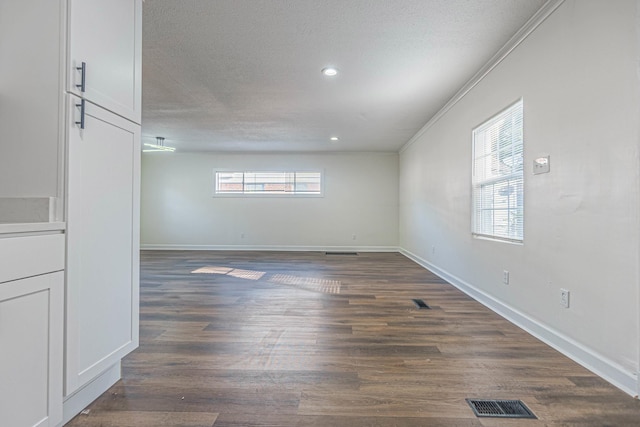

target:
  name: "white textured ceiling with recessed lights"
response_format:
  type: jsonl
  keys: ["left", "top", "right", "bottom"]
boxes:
{"left": 142, "top": 0, "right": 545, "bottom": 152}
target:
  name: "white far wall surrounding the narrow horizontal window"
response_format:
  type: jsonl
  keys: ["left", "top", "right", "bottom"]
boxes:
{"left": 141, "top": 153, "right": 398, "bottom": 250}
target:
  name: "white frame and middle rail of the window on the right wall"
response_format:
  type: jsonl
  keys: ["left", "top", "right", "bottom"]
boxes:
{"left": 471, "top": 98, "right": 525, "bottom": 245}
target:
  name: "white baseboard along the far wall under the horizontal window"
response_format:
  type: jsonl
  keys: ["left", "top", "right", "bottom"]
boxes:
{"left": 140, "top": 244, "right": 399, "bottom": 252}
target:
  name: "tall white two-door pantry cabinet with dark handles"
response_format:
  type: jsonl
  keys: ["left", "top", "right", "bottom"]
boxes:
{"left": 63, "top": 0, "right": 142, "bottom": 422}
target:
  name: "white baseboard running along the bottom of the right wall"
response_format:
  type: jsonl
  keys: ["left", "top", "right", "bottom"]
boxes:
{"left": 400, "top": 248, "right": 640, "bottom": 398}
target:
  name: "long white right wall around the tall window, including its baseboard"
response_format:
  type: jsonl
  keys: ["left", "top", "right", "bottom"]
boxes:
{"left": 400, "top": 0, "right": 640, "bottom": 394}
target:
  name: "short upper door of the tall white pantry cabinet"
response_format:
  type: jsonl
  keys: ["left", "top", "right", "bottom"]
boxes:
{"left": 67, "top": 0, "right": 142, "bottom": 123}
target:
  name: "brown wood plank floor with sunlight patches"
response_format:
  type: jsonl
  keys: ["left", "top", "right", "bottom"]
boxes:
{"left": 68, "top": 251, "right": 640, "bottom": 427}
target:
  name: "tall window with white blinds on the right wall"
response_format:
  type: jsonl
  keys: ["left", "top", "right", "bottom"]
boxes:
{"left": 472, "top": 100, "right": 524, "bottom": 242}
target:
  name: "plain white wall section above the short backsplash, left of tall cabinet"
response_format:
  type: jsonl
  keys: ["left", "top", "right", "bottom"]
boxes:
{"left": 0, "top": 1, "right": 64, "bottom": 198}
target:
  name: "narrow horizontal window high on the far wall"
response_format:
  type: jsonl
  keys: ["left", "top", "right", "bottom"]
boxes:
{"left": 215, "top": 172, "right": 322, "bottom": 195}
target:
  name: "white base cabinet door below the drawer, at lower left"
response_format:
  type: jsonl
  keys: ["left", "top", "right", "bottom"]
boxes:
{"left": 0, "top": 272, "right": 64, "bottom": 427}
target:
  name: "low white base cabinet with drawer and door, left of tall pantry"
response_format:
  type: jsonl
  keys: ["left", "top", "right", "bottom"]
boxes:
{"left": 0, "top": 234, "right": 64, "bottom": 427}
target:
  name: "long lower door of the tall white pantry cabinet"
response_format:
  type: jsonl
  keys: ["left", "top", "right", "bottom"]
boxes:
{"left": 65, "top": 95, "right": 140, "bottom": 395}
